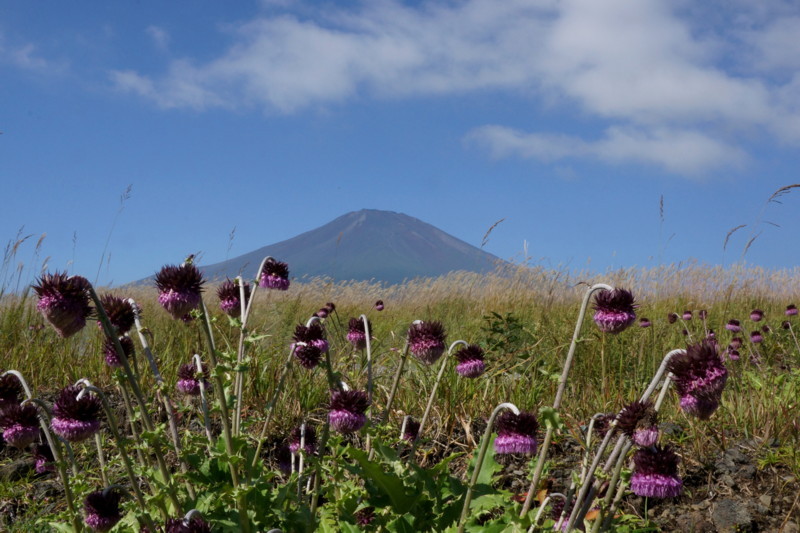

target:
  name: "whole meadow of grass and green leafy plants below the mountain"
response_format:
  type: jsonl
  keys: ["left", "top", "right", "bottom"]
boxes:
{"left": 0, "top": 265, "right": 800, "bottom": 531}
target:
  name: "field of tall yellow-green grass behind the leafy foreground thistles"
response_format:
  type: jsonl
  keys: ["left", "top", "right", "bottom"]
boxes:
{"left": 0, "top": 265, "right": 800, "bottom": 531}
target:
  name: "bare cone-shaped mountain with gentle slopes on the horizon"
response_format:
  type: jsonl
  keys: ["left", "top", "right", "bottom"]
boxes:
{"left": 201, "top": 209, "right": 500, "bottom": 284}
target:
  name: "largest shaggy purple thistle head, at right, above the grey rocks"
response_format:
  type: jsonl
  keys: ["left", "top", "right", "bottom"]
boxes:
{"left": 667, "top": 341, "right": 728, "bottom": 419}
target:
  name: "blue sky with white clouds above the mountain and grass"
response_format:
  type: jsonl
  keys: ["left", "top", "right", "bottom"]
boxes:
{"left": 0, "top": 0, "right": 800, "bottom": 283}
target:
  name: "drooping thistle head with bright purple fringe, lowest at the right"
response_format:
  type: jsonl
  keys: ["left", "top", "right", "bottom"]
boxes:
{"left": 631, "top": 446, "right": 683, "bottom": 498}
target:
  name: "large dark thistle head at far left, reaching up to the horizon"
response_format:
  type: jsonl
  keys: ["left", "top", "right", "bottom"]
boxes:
{"left": 33, "top": 272, "right": 92, "bottom": 338}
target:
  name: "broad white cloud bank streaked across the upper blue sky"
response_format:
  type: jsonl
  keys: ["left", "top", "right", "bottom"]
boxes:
{"left": 111, "top": 0, "right": 800, "bottom": 174}
